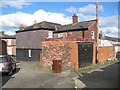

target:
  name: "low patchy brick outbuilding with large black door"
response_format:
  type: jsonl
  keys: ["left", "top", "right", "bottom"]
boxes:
{"left": 40, "top": 38, "right": 96, "bottom": 70}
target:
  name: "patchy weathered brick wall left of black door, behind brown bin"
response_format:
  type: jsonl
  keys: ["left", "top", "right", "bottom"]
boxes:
{"left": 40, "top": 40, "right": 78, "bottom": 70}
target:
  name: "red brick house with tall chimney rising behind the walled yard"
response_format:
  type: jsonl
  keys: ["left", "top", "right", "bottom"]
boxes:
{"left": 54, "top": 14, "right": 98, "bottom": 42}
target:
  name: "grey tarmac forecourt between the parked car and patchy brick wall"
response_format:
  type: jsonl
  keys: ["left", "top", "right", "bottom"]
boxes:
{"left": 2, "top": 62, "right": 74, "bottom": 90}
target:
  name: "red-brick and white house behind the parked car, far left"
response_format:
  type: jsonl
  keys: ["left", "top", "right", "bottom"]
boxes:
{"left": 0, "top": 31, "right": 16, "bottom": 56}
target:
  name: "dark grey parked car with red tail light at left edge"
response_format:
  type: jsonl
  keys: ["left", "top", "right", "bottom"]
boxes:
{"left": 0, "top": 55, "right": 16, "bottom": 75}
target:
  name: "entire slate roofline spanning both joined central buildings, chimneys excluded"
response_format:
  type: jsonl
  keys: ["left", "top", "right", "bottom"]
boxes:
{"left": 16, "top": 20, "right": 96, "bottom": 33}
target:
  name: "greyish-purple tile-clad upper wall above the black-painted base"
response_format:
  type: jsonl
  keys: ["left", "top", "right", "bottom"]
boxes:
{"left": 16, "top": 30, "right": 48, "bottom": 49}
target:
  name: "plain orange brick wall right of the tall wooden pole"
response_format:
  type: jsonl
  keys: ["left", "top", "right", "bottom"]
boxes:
{"left": 98, "top": 46, "right": 115, "bottom": 62}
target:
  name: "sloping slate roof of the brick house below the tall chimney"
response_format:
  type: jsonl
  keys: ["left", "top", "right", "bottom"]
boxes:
{"left": 55, "top": 20, "right": 96, "bottom": 33}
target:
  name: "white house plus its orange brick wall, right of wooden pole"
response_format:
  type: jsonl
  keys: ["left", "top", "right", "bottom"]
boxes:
{"left": 99, "top": 34, "right": 120, "bottom": 62}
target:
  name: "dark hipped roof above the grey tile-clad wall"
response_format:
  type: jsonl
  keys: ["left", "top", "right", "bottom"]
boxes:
{"left": 25, "top": 21, "right": 61, "bottom": 30}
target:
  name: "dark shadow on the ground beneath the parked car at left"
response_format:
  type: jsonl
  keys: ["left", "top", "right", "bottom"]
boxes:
{"left": 2, "top": 68, "right": 20, "bottom": 87}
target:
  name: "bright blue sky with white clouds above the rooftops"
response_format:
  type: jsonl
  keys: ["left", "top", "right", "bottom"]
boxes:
{"left": 0, "top": 0, "right": 120, "bottom": 37}
